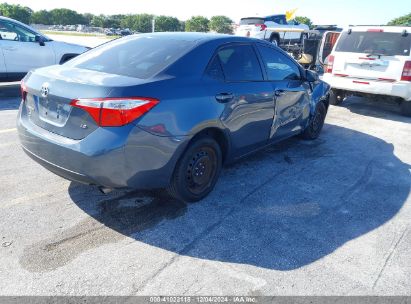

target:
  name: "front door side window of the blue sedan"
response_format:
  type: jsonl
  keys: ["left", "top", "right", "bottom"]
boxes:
{"left": 258, "top": 45, "right": 301, "bottom": 81}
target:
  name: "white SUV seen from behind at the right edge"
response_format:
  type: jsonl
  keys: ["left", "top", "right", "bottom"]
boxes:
{"left": 323, "top": 26, "right": 411, "bottom": 115}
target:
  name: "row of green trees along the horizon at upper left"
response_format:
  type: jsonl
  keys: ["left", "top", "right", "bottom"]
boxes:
{"left": 0, "top": 3, "right": 237, "bottom": 34}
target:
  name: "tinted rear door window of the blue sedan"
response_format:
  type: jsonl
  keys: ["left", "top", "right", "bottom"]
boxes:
{"left": 218, "top": 45, "right": 263, "bottom": 81}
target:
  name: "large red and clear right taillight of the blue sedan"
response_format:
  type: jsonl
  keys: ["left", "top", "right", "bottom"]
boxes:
{"left": 70, "top": 97, "right": 159, "bottom": 127}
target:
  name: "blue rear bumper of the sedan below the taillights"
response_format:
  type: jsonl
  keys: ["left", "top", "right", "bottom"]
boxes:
{"left": 17, "top": 104, "right": 186, "bottom": 189}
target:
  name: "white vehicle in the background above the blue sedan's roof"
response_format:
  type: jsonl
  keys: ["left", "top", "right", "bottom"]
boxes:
{"left": 236, "top": 15, "right": 309, "bottom": 45}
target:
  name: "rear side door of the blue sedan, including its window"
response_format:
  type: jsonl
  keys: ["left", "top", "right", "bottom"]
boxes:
{"left": 207, "top": 43, "right": 274, "bottom": 157}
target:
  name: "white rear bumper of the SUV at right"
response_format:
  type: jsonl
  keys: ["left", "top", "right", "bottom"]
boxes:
{"left": 323, "top": 73, "right": 411, "bottom": 101}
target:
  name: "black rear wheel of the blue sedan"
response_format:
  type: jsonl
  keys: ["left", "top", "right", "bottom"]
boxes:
{"left": 167, "top": 137, "right": 222, "bottom": 202}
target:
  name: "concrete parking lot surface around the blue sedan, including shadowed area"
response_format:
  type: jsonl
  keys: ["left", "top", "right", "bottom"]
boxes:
{"left": 0, "top": 89, "right": 411, "bottom": 295}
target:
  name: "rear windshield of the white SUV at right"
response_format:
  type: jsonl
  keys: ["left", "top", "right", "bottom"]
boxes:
{"left": 335, "top": 32, "right": 411, "bottom": 56}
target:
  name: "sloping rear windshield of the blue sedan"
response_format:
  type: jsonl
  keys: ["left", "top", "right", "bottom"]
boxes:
{"left": 65, "top": 35, "right": 195, "bottom": 79}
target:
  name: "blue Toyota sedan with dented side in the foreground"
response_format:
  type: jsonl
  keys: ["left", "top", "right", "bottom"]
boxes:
{"left": 18, "top": 33, "right": 330, "bottom": 201}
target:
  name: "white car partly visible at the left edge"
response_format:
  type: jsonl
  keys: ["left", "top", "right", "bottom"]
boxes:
{"left": 0, "top": 17, "right": 89, "bottom": 81}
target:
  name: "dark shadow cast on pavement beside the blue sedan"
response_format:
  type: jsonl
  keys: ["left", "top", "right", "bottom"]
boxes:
{"left": 69, "top": 125, "right": 411, "bottom": 271}
